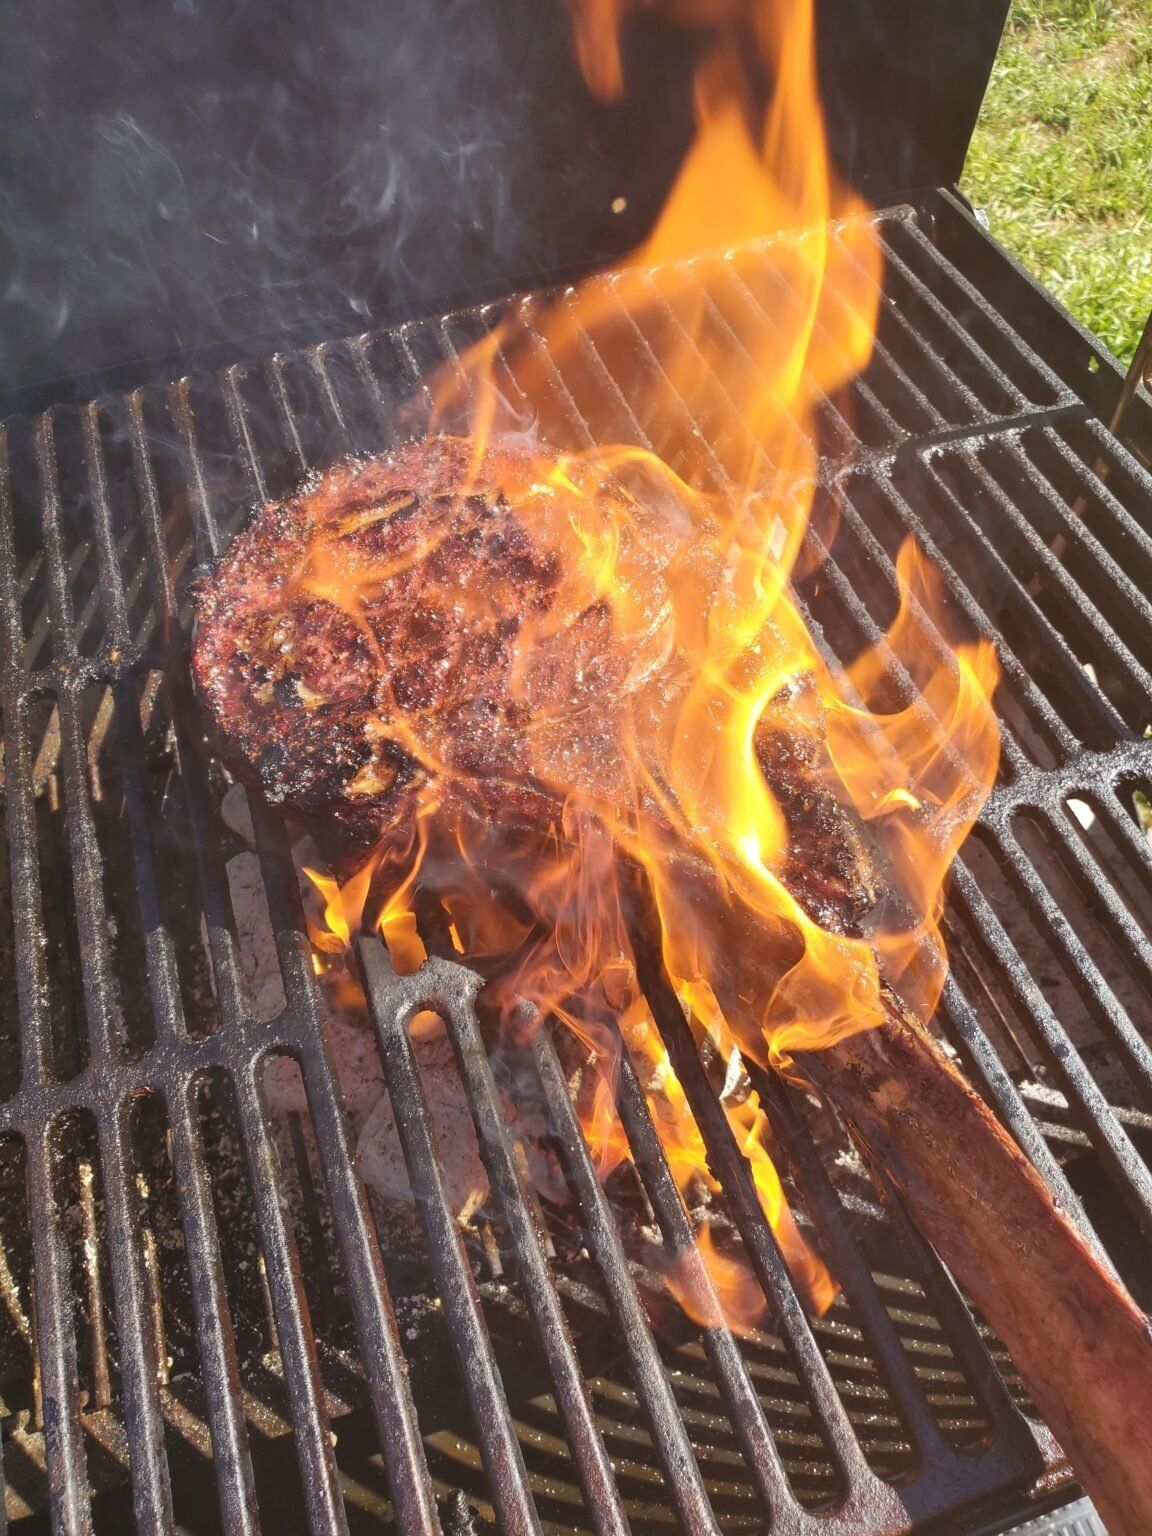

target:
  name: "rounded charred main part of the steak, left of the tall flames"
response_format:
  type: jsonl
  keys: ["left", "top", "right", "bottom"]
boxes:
{"left": 192, "top": 438, "right": 659, "bottom": 865}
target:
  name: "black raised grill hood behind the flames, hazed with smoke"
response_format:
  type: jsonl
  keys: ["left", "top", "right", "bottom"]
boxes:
{"left": 0, "top": 0, "right": 1008, "bottom": 409}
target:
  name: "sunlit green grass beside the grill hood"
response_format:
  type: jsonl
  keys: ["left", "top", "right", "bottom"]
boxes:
{"left": 962, "top": 0, "right": 1152, "bottom": 362}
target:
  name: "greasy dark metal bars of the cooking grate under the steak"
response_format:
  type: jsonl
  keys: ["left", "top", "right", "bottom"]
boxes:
{"left": 0, "top": 203, "right": 1152, "bottom": 1536}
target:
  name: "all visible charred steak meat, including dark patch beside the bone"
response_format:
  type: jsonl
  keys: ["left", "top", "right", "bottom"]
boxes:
{"left": 192, "top": 436, "right": 872, "bottom": 909}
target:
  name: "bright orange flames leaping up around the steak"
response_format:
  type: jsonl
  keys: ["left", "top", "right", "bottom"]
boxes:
{"left": 309, "top": 0, "right": 998, "bottom": 1327}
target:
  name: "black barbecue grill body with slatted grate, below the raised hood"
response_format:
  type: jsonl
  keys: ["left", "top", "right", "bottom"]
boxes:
{"left": 0, "top": 8, "right": 1152, "bottom": 1536}
